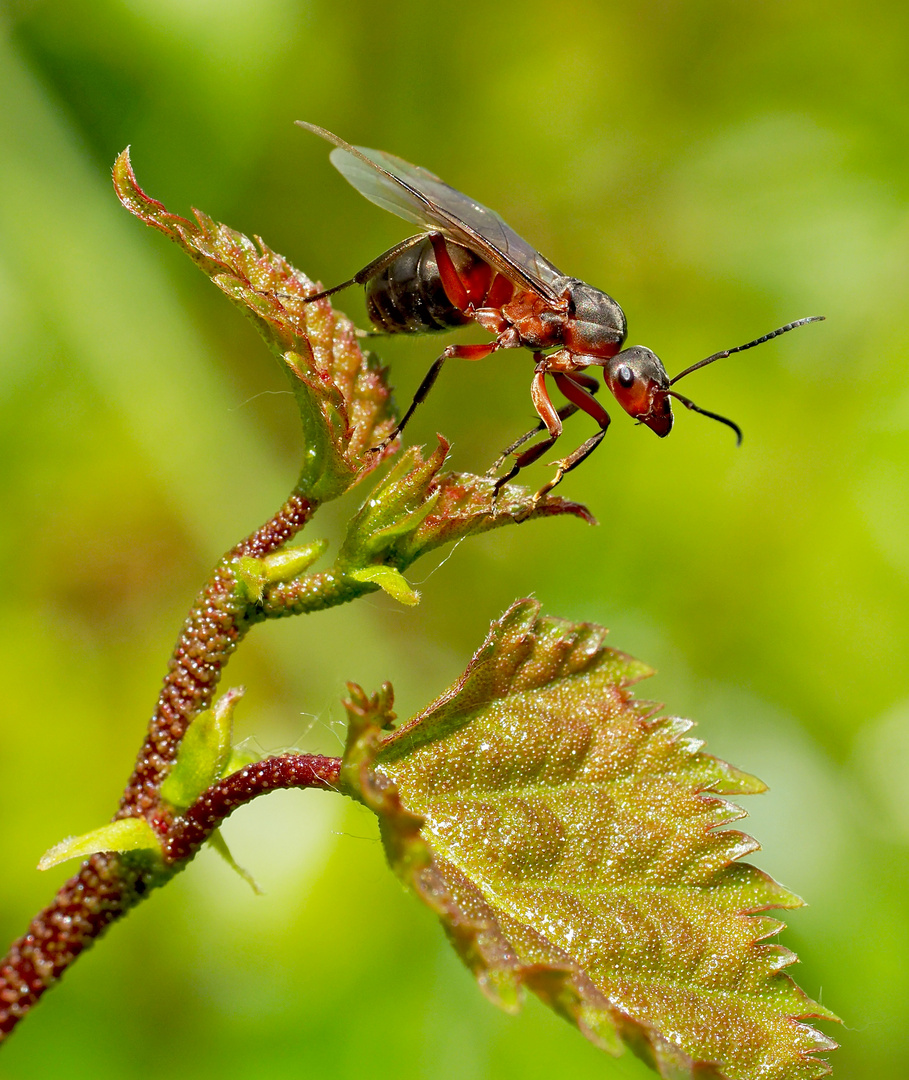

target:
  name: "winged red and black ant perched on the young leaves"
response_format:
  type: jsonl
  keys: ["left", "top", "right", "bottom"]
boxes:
{"left": 297, "top": 120, "right": 824, "bottom": 499}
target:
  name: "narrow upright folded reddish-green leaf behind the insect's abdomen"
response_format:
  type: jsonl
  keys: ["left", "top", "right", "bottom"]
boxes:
{"left": 113, "top": 149, "right": 395, "bottom": 499}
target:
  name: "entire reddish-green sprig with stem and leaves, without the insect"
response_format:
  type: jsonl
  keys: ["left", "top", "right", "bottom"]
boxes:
{"left": 0, "top": 151, "right": 836, "bottom": 1080}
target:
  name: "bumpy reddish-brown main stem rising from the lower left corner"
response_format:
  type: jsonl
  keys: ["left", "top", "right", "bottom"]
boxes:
{"left": 0, "top": 494, "right": 319, "bottom": 1040}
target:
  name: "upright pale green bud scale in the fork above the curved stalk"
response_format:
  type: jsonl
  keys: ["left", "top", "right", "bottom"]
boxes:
{"left": 161, "top": 687, "right": 244, "bottom": 811}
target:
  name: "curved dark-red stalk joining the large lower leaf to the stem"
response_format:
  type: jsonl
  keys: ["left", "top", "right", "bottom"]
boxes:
{"left": 163, "top": 754, "right": 341, "bottom": 863}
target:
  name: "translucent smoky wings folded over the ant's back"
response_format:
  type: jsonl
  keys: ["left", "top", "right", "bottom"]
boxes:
{"left": 297, "top": 120, "right": 565, "bottom": 302}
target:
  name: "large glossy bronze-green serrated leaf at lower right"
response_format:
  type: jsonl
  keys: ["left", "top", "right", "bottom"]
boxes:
{"left": 342, "top": 600, "right": 837, "bottom": 1080}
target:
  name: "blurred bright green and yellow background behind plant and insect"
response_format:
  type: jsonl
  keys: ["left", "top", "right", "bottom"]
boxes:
{"left": 0, "top": 0, "right": 909, "bottom": 1080}
